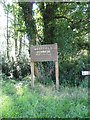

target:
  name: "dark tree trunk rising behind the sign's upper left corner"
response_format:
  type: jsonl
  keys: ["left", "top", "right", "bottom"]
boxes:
{"left": 19, "top": 2, "right": 36, "bottom": 56}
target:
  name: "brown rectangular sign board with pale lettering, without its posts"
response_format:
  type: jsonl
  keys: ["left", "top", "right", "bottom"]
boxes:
{"left": 31, "top": 44, "right": 58, "bottom": 62}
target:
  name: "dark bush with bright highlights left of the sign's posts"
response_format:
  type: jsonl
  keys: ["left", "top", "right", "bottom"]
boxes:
{"left": 2, "top": 56, "right": 30, "bottom": 79}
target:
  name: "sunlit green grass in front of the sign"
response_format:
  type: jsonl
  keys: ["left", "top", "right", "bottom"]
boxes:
{"left": 0, "top": 80, "right": 88, "bottom": 118}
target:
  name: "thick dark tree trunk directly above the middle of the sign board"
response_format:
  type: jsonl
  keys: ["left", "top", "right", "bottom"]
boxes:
{"left": 39, "top": 3, "right": 57, "bottom": 44}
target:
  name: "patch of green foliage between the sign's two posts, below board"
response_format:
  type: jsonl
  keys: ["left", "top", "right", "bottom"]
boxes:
{"left": 37, "top": 61, "right": 55, "bottom": 84}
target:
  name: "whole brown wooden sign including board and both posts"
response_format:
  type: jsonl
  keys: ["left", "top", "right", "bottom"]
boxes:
{"left": 31, "top": 43, "right": 59, "bottom": 90}
